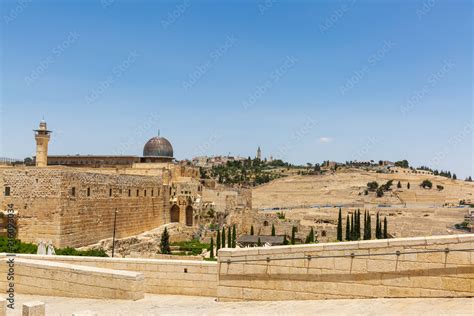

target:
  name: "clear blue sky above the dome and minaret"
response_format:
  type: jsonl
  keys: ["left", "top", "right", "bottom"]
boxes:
{"left": 0, "top": 0, "right": 474, "bottom": 177}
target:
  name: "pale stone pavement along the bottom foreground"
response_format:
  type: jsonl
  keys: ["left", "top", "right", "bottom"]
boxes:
{"left": 7, "top": 295, "right": 474, "bottom": 316}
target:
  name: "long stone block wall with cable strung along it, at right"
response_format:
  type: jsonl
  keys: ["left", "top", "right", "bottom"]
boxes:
{"left": 217, "top": 234, "right": 474, "bottom": 301}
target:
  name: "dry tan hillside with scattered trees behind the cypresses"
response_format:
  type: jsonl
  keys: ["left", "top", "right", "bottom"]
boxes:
{"left": 253, "top": 169, "right": 474, "bottom": 237}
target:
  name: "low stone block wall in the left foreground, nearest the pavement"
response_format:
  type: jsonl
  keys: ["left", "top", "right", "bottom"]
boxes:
{"left": 0, "top": 255, "right": 144, "bottom": 300}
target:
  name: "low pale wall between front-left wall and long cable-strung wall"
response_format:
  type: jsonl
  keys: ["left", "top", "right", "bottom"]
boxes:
{"left": 10, "top": 255, "right": 218, "bottom": 297}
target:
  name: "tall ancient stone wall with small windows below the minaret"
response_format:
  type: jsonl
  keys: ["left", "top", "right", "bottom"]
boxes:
{"left": 0, "top": 167, "right": 169, "bottom": 247}
